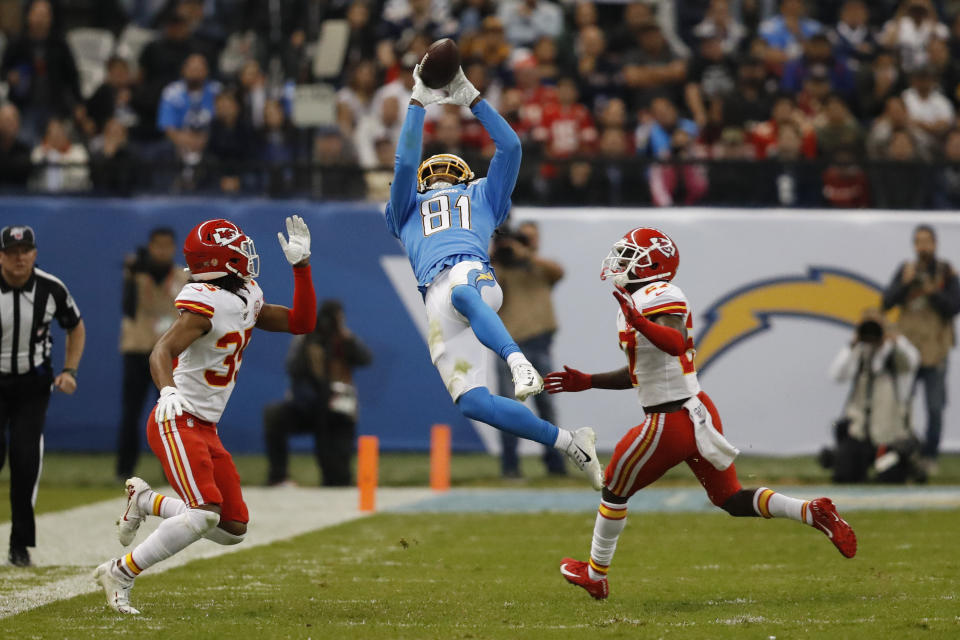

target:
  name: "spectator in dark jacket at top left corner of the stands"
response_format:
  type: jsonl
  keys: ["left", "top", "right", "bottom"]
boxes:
{"left": 0, "top": 0, "right": 80, "bottom": 142}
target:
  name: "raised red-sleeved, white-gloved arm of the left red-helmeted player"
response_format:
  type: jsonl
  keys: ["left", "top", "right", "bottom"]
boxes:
{"left": 256, "top": 216, "right": 317, "bottom": 335}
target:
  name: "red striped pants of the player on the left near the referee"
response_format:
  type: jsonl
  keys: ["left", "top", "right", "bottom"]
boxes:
{"left": 147, "top": 411, "right": 250, "bottom": 523}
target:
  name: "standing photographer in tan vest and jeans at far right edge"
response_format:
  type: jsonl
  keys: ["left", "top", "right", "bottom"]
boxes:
{"left": 883, "top": 224, "right": 960, "bottom": 473}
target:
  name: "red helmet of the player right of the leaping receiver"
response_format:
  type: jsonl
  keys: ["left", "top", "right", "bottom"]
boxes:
{"left": 600, "top": 227, "right": 680, "bottom": 286}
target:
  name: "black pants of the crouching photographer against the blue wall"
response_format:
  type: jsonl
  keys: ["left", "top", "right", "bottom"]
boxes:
{"left": 263, "top": 402, "right": 356, "bottom": 487}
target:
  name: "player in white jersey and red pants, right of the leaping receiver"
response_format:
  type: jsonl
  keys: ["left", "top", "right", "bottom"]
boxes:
{"left": 546, "top": 227, "right": 857, "bottom": 599}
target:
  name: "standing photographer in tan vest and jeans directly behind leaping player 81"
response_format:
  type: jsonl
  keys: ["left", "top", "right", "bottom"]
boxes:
{"left": 490, "top": 221, "right": 567, "bottom": 478}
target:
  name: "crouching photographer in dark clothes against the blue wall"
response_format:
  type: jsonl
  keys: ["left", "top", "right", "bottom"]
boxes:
{"left": 263, "top": 300, "right": 373, "bottom": 487}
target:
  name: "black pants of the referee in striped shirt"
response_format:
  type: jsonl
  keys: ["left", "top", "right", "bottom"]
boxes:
{"left": 0, "top": 373, "right": 53, "bottom": 547}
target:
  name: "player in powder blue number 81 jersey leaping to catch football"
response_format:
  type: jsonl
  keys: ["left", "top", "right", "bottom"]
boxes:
{"left": 386, "top": 65, "right": 603, "bottom": 490}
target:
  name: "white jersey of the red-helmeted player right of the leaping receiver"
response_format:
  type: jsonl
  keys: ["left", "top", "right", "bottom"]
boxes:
{"left": 617, "top": 282, "right": 700, "bottom": 407}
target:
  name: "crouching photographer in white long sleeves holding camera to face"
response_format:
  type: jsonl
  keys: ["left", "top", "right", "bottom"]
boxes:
{"left": 821, "top": 310, "right": 926, "bottom": 482}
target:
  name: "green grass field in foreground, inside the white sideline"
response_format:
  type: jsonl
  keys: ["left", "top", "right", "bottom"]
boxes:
{"left": 0, "top": 510, "right": 960, "bottom": 640}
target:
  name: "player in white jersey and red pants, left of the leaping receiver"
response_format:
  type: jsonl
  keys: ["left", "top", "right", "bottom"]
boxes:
{"left": 94, "top": 216, "right": 317, "bottom": 614}
